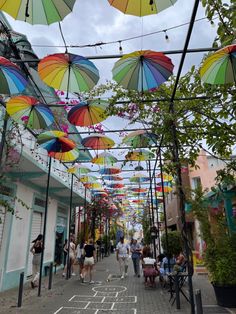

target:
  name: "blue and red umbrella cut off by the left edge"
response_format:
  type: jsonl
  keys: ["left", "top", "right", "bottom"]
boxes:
{"left": 0, "top": 57, "right": 28, "bottom": 95}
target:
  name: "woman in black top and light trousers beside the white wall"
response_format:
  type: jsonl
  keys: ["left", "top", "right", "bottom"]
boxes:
{"left": 30, "top": 234, "right": 44, "bottom": 289}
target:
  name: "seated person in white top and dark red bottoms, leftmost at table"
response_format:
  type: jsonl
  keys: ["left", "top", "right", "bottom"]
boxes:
{"left": 142, "top": 253, "right": 158, "bottom": 287}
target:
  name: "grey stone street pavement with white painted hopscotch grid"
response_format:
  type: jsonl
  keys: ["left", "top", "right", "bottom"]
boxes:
{"left": 0, "top": 254, "right": 236, "bottom": 314}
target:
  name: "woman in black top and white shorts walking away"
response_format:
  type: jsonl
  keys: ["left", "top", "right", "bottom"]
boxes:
{"left": 80, "top": 239, "right": 96, "bottom": 284}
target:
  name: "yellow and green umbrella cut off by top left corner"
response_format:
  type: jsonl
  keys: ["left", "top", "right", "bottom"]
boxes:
{"left": 0, "top": 0, "right": 75, "bottom": 25}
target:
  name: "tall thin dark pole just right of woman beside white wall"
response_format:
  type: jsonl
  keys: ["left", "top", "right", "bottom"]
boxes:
{"left": 38, "top": 157, "right": 52, "bottom": 297}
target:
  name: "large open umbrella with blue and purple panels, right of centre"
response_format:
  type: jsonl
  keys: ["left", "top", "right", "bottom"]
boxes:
{"left": 112, "top": 50, "right": 174, "bottom": 92}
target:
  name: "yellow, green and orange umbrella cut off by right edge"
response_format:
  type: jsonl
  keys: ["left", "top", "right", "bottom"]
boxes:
{"left": 200, "top": 44, "right": 236, "bottom": 85}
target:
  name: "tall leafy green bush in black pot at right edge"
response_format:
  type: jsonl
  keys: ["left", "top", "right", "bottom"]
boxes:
{"left": 190, "top": 187, "right": 236, "bottom": 307}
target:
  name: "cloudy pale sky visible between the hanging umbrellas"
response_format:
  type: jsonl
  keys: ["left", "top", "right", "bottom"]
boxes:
{"left": 0, "top": 0, "right": 219, "bottom": 213}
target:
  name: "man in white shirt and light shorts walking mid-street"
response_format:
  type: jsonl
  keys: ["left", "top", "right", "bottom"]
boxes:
{"left": 116, "top": 237, "right": 129, "bottom": 279}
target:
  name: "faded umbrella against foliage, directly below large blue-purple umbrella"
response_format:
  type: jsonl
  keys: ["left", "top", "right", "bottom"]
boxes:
{"left": 122, "top": 130, "right": 158, "bottom": 148}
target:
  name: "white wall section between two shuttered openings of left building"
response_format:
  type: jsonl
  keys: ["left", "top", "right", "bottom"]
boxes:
{"left": 6, "top": 183, "right": 33, "bottom": 272}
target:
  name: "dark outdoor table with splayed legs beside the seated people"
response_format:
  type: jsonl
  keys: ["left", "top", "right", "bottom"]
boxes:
{"left": 167, "top": 272, "right": 190, "bottom": 310}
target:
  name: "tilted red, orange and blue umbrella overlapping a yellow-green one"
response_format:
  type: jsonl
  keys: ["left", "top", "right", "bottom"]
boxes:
{"left": 37, "top": 130, "right": 76, "bottom": 153}
